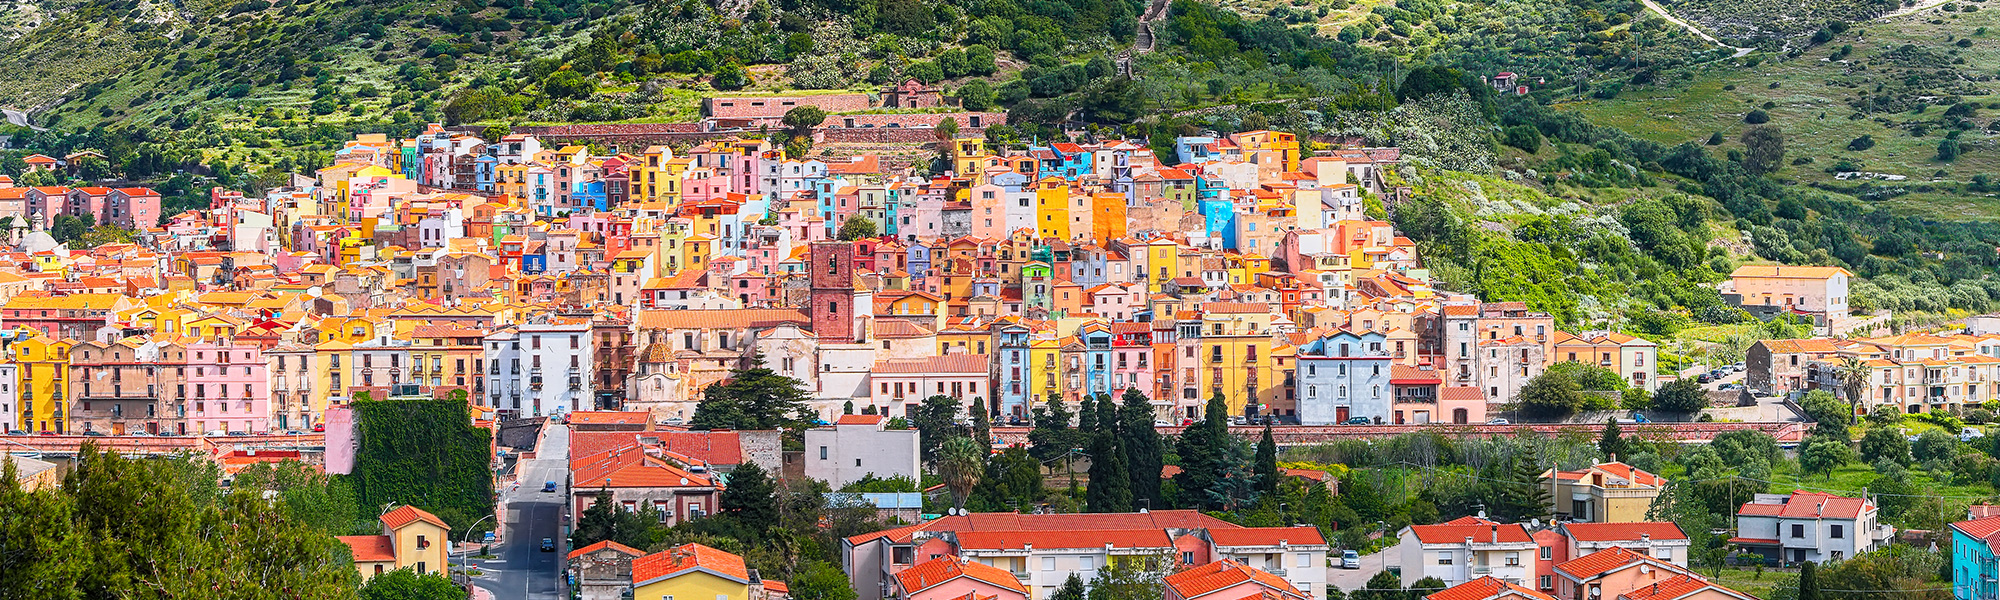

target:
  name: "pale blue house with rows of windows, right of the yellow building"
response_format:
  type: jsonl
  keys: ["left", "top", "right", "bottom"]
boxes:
{"left": 1296, "top": 332, "right": 1396, "bottom": 424}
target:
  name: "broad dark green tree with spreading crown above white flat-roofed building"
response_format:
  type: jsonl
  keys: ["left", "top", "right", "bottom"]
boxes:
{"left": 688, "top": 356, "right": 814, "bottom": 430}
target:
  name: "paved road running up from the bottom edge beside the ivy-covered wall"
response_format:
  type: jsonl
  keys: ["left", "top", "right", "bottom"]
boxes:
{"left": 474, "top": 424, "right": 570, "bottom": 600}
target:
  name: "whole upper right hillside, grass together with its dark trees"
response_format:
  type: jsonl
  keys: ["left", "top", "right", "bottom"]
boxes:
{"left": 1560, "top": 4, "right": 2000, "bottom": 220}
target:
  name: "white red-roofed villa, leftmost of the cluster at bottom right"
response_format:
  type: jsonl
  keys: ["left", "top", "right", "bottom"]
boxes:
{"left": 1398, "top": 516, "right": 1540, "bottom": 586}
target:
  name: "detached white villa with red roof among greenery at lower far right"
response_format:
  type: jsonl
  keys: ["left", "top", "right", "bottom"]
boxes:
{"left": 1730, "top": 492, "right": 1896, "bottom": 562}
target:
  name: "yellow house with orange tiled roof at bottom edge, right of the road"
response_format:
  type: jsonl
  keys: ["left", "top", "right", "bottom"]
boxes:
{"left": 632, "top": 544, "right": 784, "bottom": 600}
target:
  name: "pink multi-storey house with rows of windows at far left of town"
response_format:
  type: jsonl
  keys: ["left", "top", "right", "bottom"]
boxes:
{"left": 188, "top": 338, "right": 270, "bottom": 432}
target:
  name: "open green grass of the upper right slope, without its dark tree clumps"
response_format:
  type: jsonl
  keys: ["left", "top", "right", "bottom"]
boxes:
{"left": 1562, "top": 10, "right": 2000, "bottom": 220}
